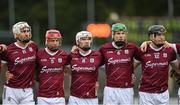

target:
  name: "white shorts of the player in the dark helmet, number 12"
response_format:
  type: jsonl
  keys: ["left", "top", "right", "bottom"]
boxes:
{"left": 139, "top": 90, "right": 169, "bottom": 105}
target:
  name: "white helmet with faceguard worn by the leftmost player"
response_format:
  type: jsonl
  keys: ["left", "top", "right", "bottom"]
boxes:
{"left": 12, "top": 22, "right": 32, "bottom": 43}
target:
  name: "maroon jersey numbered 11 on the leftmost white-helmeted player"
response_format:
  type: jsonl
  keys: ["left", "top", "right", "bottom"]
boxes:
{"left": 3, "top": 42, "right": 38, "bottom": 88}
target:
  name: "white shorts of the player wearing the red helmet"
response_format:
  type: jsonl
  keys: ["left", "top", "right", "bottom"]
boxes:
{"left": 37, "top": 97, "right": 65, "bottom": 105}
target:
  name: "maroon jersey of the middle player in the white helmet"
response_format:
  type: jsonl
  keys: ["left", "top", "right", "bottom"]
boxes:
{"left": 69, "top": 51, "right": 102, "bottom": 98}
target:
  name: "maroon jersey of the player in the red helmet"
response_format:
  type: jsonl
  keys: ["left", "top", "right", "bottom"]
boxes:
{"left": 37, "top": 48, "right": 68, "bottom": 98}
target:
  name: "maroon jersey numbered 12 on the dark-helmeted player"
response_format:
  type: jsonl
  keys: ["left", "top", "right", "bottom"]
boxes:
{"left": 136, "top": 46, "right": 176, "bottom": 93}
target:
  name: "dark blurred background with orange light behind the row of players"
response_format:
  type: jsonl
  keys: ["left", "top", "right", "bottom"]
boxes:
{"left": 0, "top": 0, "right": 180, "bottom": 104}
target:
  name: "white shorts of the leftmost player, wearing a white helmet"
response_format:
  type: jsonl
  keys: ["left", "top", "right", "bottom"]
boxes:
{"left": 2, "top": 86, "right": 35, "bottom": 105}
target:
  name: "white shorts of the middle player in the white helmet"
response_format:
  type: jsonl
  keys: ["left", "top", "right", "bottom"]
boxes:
{"left": 68, "top": 96, "right": 98, "bottom": 105}
